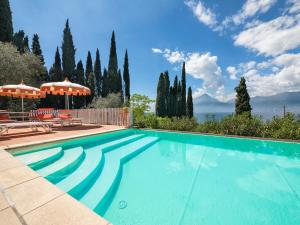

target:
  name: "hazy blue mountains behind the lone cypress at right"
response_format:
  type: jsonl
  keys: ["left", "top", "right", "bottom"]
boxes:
{"left": 194, "top": 92, "right": 300, "bottom": 118}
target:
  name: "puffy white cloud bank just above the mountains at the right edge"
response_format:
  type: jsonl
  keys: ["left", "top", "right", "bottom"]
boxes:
{"left": 230, "top": 53, "right": 300, "bottom": 96}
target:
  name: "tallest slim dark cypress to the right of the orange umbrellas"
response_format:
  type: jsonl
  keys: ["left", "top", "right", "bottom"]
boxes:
{"left": 107, "top": 31, "right": 119, "bottom": 93}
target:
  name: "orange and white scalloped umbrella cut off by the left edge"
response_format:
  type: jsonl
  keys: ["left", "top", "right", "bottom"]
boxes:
{"left": 0, "top": 81, "right": 45, "bottom": 112}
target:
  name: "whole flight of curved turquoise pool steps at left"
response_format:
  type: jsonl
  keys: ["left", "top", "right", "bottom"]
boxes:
{"left": 16, "top": 134, "right": 160, "bottom": 215}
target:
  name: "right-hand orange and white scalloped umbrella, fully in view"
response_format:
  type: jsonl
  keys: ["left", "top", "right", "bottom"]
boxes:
{"left": 40, "top": 78, "right": 91, "bottom": 108}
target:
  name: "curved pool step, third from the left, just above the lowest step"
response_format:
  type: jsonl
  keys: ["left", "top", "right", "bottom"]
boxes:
{"left": 56, "top": 135, "right": 143, "bottom": 198}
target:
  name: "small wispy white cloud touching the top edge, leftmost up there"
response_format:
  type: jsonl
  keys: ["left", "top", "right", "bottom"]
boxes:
{"left": 184, "top": 0, "right": 217, "bottom": 27}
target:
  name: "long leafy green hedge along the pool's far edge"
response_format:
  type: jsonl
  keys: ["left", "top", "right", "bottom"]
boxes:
{"left": 135, "top": 110, "right": 300, "bottom": 139}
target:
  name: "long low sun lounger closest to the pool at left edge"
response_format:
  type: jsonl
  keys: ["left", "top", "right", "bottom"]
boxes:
{"left": 0, "top": 122, "right": 53, "bottom": 135}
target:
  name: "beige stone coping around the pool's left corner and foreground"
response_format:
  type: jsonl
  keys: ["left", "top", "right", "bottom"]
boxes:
{"left": 0, "top": 127, "right": 127, "bottom": 225}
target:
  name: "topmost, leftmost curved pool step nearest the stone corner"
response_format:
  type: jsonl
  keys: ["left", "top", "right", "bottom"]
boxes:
{"left": 16, "top": 147, "right": 64, "bottom": 170}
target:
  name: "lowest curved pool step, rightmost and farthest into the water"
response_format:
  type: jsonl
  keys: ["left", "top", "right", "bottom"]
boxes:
{"left": 80, "top": 137, "right": 159, "bottom": 214}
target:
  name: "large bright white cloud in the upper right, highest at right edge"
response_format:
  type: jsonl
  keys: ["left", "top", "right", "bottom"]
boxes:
{"left": 234, "top": 14, "right": 300, "bottom": 56}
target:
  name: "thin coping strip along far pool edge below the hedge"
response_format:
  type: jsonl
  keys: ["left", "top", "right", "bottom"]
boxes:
{"left": 138, "top": 127, "right": 300, "bottom": 144}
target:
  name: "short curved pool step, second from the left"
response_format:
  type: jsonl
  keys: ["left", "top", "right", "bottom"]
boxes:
{"left": 37, "top": 147, "right": 85, "bottom": 183}
